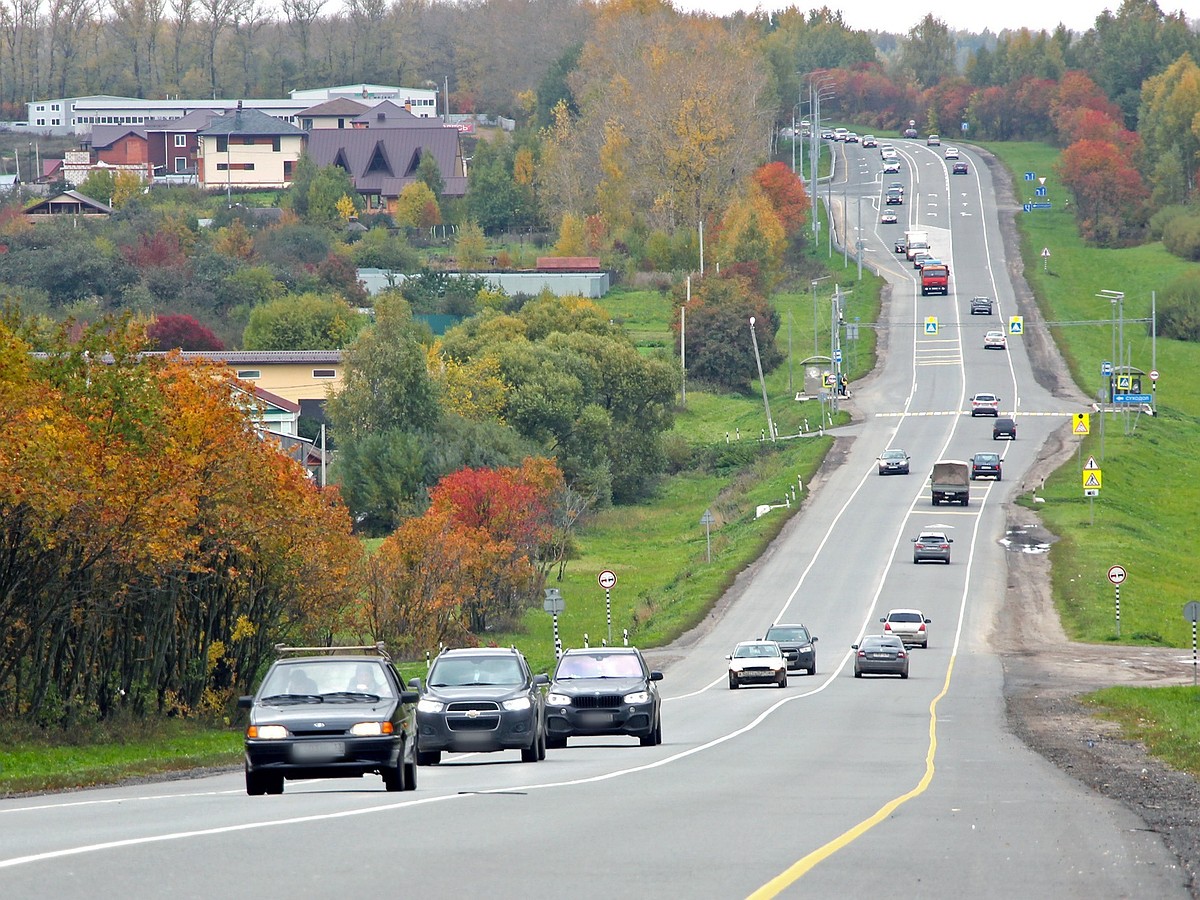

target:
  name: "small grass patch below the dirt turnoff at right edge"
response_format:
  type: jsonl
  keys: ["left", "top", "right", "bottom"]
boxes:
{"left": 1084, "top": 685, "right": 1200, "bottom": 778}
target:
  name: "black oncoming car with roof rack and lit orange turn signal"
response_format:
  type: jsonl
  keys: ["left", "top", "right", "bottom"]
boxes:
{"left": 238, "top": 644, "right": 416, "bottom": 797}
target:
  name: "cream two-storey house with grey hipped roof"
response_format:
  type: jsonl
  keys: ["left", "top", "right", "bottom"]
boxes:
{"left": 196, "top": 108, "right": 306, "bottom": 190}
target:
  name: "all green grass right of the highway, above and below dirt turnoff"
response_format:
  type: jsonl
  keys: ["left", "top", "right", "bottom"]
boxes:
{"left": 989, "top": 143, "right": 1200, "bottom": 775}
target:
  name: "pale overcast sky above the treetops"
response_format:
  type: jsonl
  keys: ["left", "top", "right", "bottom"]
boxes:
{"left": 673, "top": 0, "right": 1128, "bottom": 34}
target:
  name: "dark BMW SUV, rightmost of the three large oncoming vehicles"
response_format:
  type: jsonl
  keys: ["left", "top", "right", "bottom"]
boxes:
{"left": 546, "top": 647, "right": 662, "bottom": 748}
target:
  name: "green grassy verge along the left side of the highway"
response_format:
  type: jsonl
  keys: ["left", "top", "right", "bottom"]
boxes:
{"left": 0, "top": 180, "right": 882, "bottom": 794}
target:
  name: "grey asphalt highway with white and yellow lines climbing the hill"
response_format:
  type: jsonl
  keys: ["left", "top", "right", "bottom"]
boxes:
{"left": 0, "top": 140, "right": 1187, "bottom": 899}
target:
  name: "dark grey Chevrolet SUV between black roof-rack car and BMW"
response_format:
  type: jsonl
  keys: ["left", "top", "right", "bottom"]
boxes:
{"left": 409, "top": 647, "right": 550, "bottom": 766}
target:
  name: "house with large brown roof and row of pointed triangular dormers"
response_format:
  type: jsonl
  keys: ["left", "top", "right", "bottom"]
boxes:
{"left": 307, "top": 120, "right": 467, "bottom": 212}
